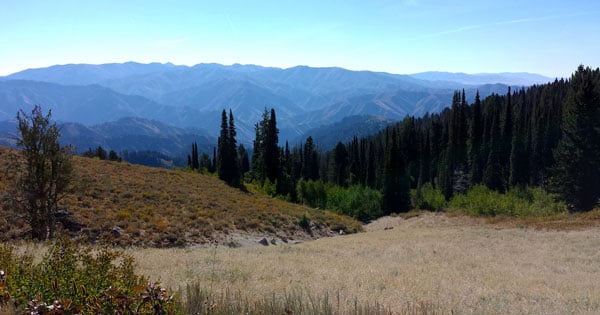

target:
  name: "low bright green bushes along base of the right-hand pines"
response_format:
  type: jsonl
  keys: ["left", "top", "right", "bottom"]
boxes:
{"left": 412, "top": 184, "right": 567, "bottom": 218}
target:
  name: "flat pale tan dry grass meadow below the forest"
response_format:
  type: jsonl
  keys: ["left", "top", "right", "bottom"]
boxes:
{"left": 131, "top": 213, "right": 600, "bottom": 314}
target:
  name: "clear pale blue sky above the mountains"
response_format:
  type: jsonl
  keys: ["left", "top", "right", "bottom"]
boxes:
{"left": 0, "top": 0, "right": 600, "bottom": 77}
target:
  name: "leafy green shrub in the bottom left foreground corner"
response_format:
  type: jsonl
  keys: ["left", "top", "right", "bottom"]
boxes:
{"left": 0, "top": 239, "right": 176, "bottom": 314}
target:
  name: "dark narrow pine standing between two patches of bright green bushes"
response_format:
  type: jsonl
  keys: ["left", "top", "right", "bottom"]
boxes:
{"left": 382, "top": 129, "right": 410, "bottom": 214}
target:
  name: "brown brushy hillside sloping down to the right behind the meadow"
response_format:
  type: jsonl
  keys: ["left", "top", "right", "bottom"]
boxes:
{"left": 0, "top": 147, "right": 361, "bottom": 247}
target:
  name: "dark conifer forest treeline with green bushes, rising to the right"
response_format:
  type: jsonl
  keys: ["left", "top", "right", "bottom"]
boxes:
{"left": 196, "top": 66, "right": 600, "bottom": 220}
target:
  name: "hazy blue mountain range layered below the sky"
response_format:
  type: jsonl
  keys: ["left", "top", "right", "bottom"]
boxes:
{"left": 0, "top": 62, "right": 552, "bottom": 154}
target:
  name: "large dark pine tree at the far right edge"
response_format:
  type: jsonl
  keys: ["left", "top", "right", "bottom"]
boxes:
{"left": 552, "top": 66, "right": 600, "bottom": 211}
